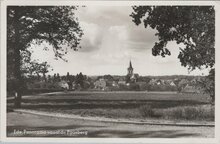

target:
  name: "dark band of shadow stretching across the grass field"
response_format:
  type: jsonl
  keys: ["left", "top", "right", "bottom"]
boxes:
{"left": 9, "top": 99, "right": 207, "bottom": 110}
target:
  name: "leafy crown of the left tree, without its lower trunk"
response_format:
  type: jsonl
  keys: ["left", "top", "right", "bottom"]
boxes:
{"left": 7, "top": 6, "right": 83, "bottom": 58}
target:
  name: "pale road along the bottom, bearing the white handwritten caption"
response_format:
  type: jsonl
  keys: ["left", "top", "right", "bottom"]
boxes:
{"left": 7, "top": 112, "right": 214, "bottom": 138}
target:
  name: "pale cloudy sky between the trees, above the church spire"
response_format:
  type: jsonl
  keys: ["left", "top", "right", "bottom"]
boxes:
{"left": 31, "top": 6, "right": 208, "bottom": 76}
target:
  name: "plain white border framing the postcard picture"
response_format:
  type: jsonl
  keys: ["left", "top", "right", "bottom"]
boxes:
{"left": 0, "top": 0, "right": 220, "bottom": 144}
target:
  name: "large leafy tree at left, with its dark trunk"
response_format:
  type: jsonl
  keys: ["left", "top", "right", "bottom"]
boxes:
{"left": 7, "top": 6, "right": 83, "bottom": 107}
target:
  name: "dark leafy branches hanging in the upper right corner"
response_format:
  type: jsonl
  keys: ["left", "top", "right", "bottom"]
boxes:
{"left": 130, "top": 6, "right": 215, "bottom": 102}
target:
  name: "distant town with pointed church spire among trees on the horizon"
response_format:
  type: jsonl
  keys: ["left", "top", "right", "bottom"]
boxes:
{"left": 16, "top": 61, "right": 201, "bottom": 93}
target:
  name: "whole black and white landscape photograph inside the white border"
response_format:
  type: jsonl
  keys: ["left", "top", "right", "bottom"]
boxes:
{"left": 1, "top": 2, "right": 217, "bottom": 143}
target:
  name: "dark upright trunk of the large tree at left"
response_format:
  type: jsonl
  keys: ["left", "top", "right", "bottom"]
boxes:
{"left": 13, "top": 7, "right": 22, "bottom": 108}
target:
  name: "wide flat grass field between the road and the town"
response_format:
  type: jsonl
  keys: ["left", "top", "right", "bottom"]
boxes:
{"left": 7, "top": 92, "right": 214, "bottom": 121}
